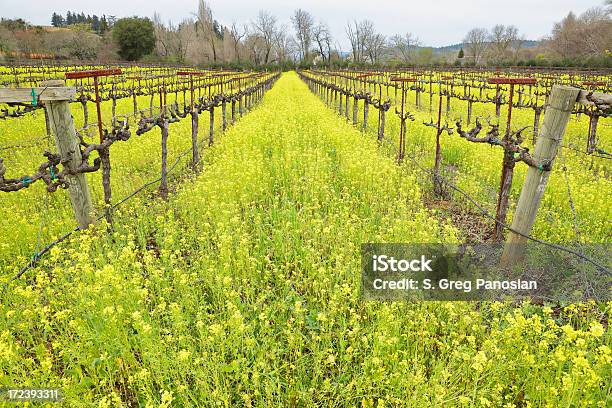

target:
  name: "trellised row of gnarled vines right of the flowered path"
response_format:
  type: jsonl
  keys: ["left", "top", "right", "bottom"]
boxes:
{"left": 298, "top": 70, "right": 612, "bottom": 274}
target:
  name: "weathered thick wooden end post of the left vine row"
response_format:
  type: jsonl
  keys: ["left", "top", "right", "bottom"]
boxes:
{"left": 41, "top": 80, "right": 93, "bottom": 229}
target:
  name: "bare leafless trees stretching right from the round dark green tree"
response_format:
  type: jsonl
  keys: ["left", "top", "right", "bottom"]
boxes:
{"left": 143, "top": 0, "right": 612, "bottom": 66}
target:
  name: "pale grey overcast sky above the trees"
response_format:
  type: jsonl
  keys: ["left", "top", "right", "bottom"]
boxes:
{"left": 0, "top": 0, "right": 603, "bottom": 50}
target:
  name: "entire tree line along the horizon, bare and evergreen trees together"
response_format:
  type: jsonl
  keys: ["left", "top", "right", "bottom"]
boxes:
{"left": 0, "top": 0, "right": 612, "bottom": 67}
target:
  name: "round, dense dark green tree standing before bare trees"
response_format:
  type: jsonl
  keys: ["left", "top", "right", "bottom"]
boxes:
{"left": 112, "top": 17, "right": 155, "bottom": 61}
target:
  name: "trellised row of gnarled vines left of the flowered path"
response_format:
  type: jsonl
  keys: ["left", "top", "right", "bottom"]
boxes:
{"left": 0, "top": 69, "right": 280, "bottom": 275}
